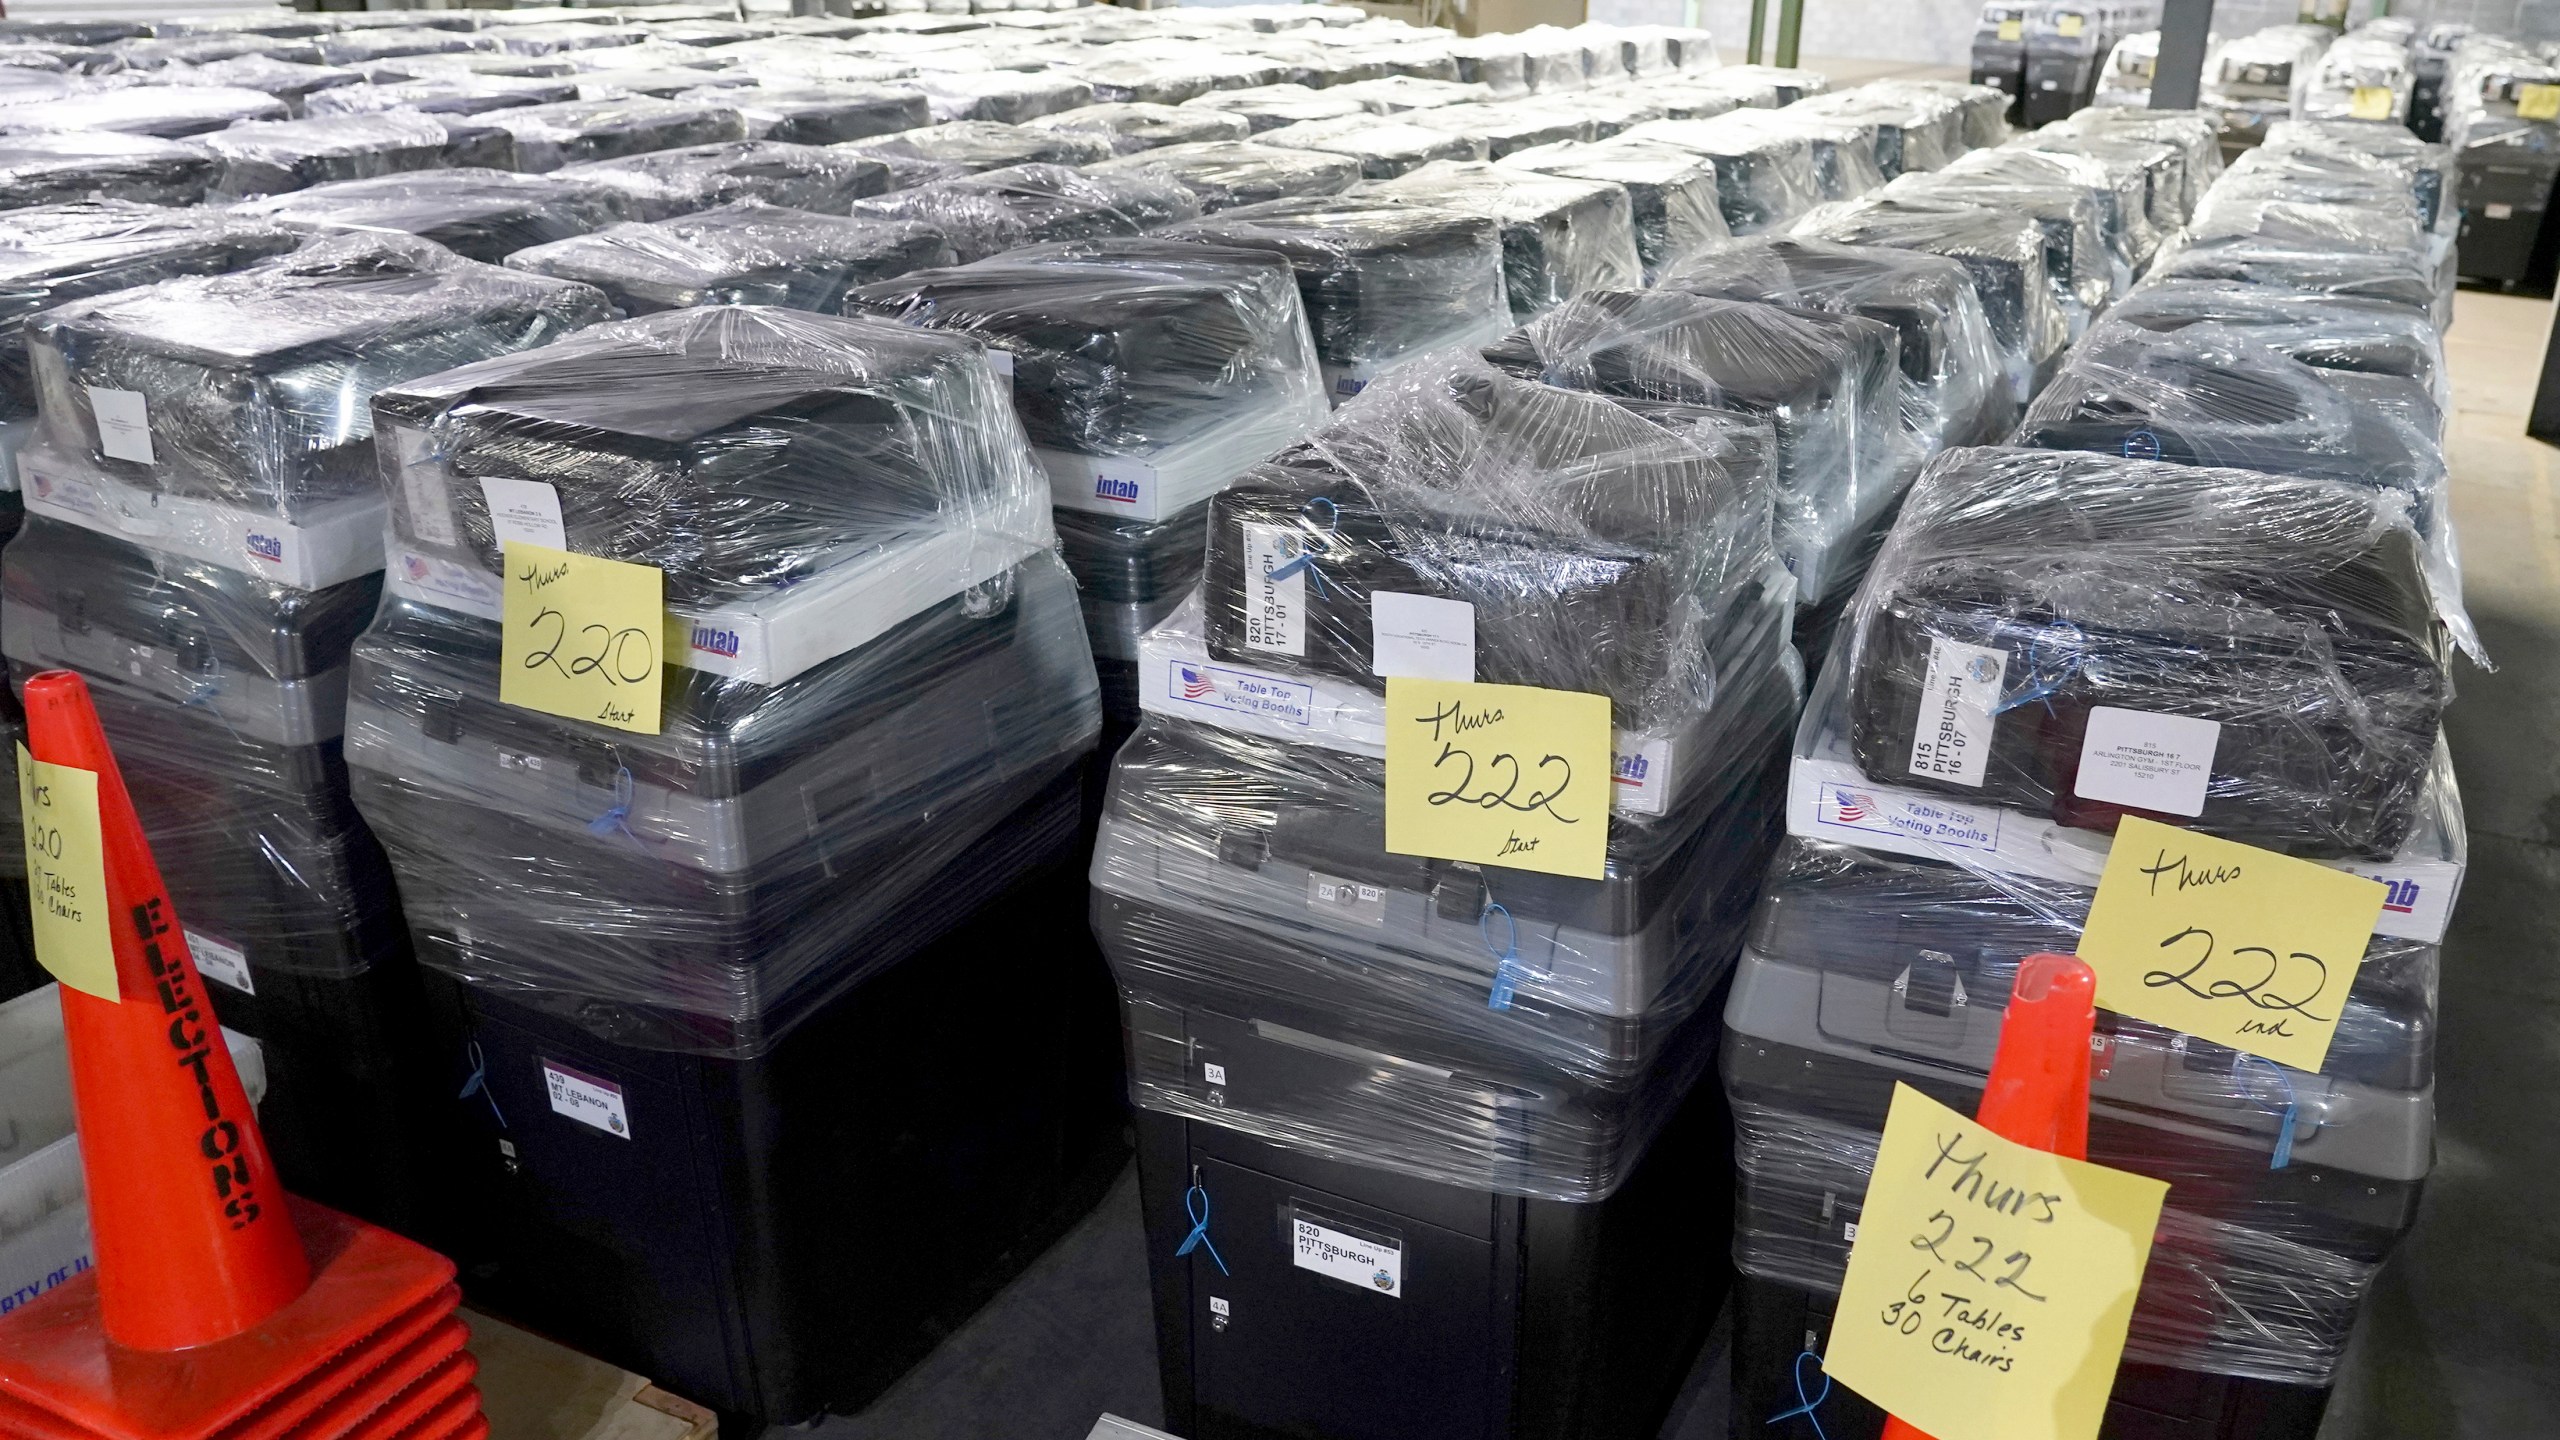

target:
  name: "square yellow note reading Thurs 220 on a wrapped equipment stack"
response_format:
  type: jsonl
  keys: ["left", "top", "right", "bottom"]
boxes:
{"left": 497, "top": 543, "right": 668, "bottom": 735}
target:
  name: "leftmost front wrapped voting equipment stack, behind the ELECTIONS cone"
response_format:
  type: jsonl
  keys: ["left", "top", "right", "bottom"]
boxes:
{"left": 0, "top": 233, "right": 609, "bottom": 1225}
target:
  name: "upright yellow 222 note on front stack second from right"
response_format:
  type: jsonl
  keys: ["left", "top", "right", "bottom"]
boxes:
{"left": 1388, "top": 676, "right": 1610, "bottom": 879}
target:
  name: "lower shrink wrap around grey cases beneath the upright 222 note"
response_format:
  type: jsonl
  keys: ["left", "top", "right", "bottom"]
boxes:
{"left": 1093, "top": 671, "right": 1792, "bottom": 1202}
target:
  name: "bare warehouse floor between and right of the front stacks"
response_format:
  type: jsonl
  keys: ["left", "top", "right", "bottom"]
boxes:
{"left": 793, "top": 292, "right": 2560, "bottom": 1440}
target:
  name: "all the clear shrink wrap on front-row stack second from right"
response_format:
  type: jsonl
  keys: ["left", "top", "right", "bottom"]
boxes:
{"left": 1093, "top": 356, "right": 1800, "bottom": 1199}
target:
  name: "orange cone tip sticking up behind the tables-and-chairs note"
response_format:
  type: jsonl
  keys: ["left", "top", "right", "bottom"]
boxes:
{"left": 1884, "top": 953, "right": 2097, "bottom": 1440}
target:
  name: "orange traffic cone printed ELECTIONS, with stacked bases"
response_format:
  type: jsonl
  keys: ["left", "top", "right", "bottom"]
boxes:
{"left": 0, "top": 671, "right": 489, "bottom": 1440}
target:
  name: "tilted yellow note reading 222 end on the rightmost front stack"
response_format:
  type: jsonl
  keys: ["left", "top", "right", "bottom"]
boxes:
{"left": 2079, "top": 817, "right": 2383, "bottom": 1071}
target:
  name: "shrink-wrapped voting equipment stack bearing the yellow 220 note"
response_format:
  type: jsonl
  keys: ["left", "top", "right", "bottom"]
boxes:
{"left": 348, "top": 305, "right": 1124, "bottom": 1420}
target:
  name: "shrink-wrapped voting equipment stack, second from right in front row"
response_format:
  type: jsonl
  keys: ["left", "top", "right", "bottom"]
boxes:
{"left": 1093, "top": 351, "right": 1802, "bottom": 1437}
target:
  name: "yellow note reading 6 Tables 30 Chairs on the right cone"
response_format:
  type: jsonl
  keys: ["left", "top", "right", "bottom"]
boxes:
{"left": 1823, "top": 1084, "right": 2168, "bottom": 1440}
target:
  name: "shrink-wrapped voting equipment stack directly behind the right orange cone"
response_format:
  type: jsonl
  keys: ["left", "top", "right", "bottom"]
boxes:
{"left": 1723, "top": 451, "right": 2465, "bottom": 1437}
